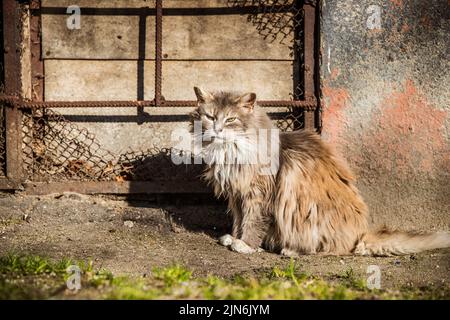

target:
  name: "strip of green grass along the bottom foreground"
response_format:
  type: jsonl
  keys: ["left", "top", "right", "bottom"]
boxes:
{"left": 0, "top": 254, "right": 449, "bottom": 299}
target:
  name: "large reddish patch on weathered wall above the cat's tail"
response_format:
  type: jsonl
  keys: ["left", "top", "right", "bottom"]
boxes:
{"left": 361, "top": 80, "right": 450, "bottom": 177}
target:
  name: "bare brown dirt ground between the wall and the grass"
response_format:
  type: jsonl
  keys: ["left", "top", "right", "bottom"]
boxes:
{"left": 0, "top": 193, "right": 450, "bottom": 290}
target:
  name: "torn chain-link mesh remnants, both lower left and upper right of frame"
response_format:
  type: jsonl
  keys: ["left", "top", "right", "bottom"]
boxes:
{"left": 16, "top": 0, "right": 304, "bottom": 182}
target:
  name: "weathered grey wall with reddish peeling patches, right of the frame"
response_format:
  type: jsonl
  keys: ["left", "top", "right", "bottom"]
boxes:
{"left": 321, "top": 0, "right": 450, "bottom": 229}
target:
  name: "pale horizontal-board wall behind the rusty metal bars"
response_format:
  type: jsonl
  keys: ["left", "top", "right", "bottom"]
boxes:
{"left": 42, "top": 0, "right": 293, "bottom": 154}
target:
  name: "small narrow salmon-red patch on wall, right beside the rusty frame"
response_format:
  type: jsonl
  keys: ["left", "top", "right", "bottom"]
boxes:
{"left": 322, "top": 85, "right": 350, "bottom": 152}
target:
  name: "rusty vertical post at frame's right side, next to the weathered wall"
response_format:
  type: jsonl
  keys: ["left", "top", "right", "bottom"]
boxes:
{"left": 303, "top": 2, "right": 316, "bottom": 129}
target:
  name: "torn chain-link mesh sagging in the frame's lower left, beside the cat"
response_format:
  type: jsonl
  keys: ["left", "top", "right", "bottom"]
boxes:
{"left": 23, "top": 109, "right": 202, "bottom": 181}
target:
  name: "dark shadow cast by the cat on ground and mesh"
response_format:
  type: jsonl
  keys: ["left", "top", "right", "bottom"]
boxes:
{"left": 121, "top": 149, "right": 231, "bottom": 237}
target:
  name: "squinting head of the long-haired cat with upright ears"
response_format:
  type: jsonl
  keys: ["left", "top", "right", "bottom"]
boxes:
{"left": 191, "top": 87, "right": 271, "bottom": 142}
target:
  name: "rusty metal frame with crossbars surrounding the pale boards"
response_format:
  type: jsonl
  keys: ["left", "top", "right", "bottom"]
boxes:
{"left": 0, "top": 0, "right": 321, "bottom": 194}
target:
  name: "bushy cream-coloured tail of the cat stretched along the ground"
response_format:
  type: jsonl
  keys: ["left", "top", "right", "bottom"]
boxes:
{"left": 354, "top": 228, "right": 450, "bottom": 256}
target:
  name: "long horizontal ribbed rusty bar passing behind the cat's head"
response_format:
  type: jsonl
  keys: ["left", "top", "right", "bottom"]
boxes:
{"left": 0, "top": 95, "right": 317, "bottom": 110}
